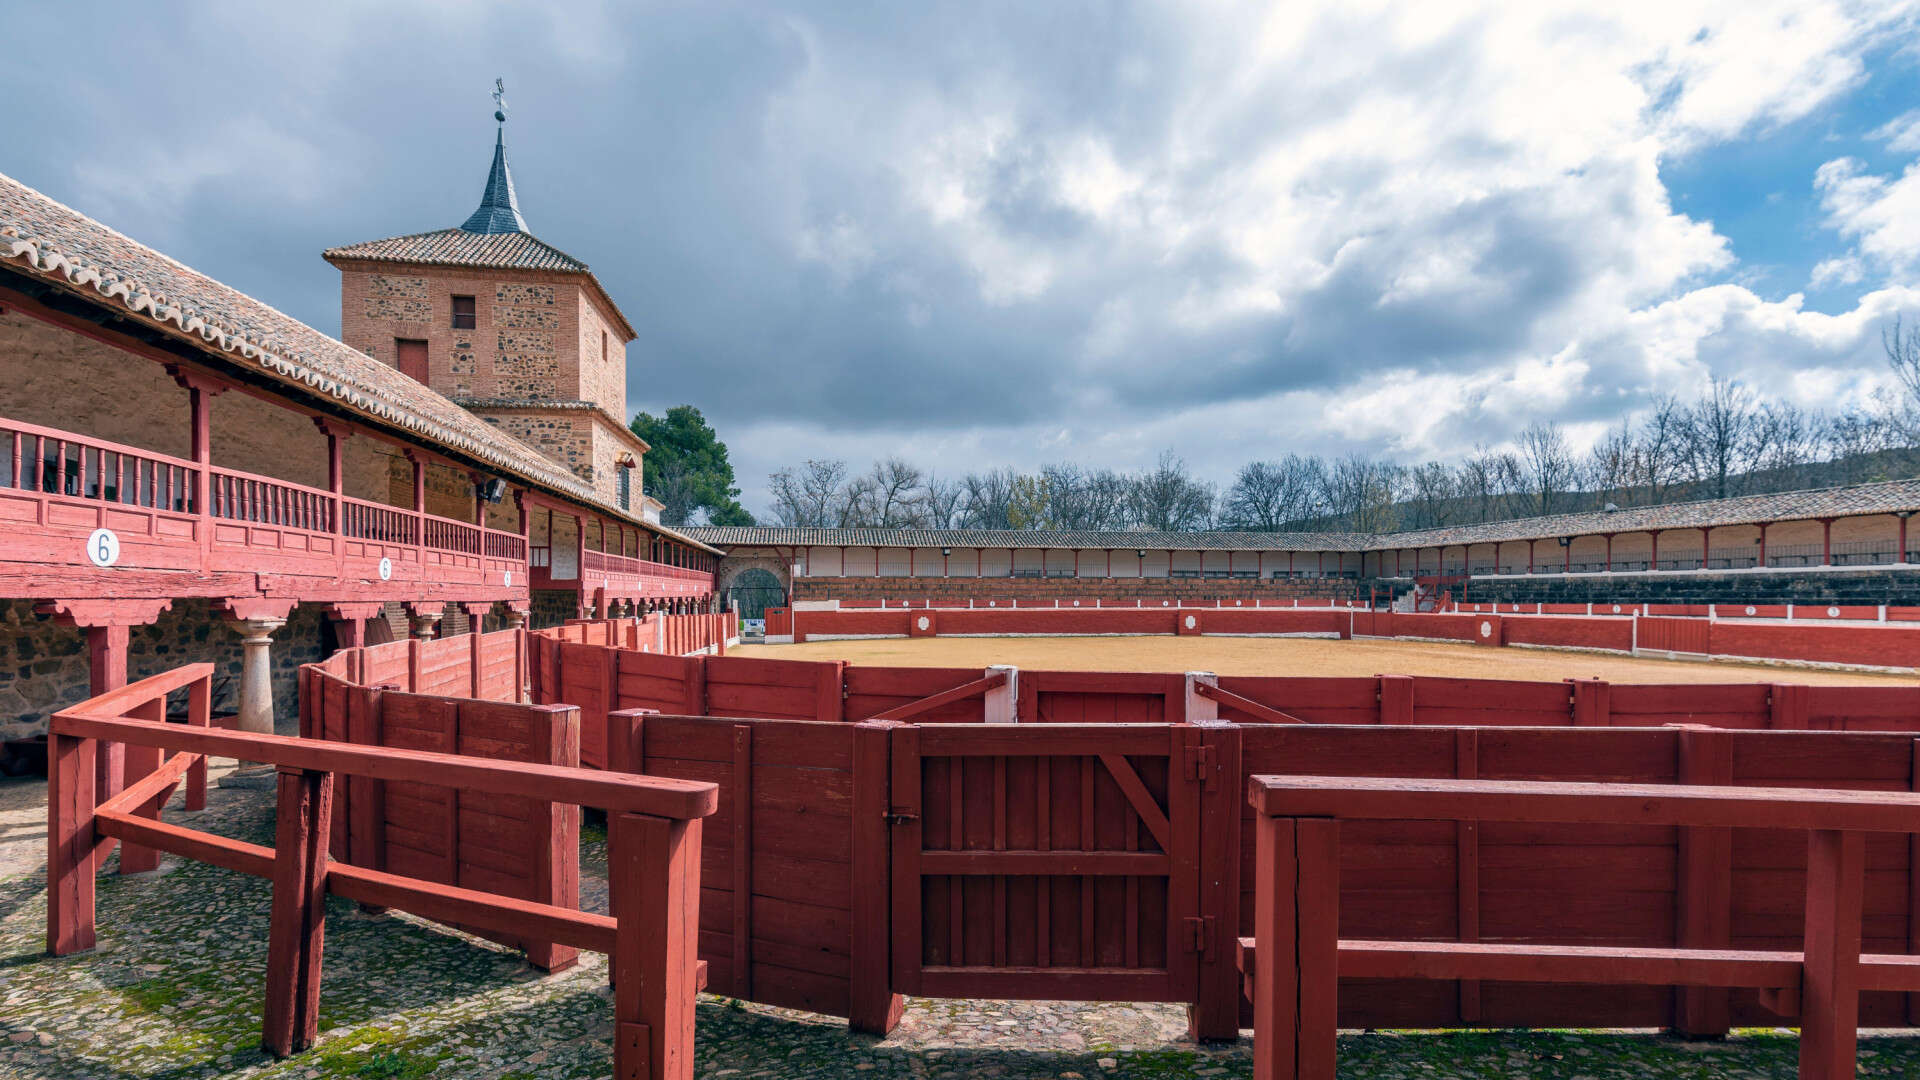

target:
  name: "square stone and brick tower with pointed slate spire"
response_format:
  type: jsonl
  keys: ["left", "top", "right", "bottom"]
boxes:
{"left": 324, "top": 96, "right": 647, "bottom": 513}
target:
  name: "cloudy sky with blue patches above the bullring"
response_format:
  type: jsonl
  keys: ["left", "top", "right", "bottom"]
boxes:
{"left": 11, "top": 0, "right": 1920, "bottom": 511}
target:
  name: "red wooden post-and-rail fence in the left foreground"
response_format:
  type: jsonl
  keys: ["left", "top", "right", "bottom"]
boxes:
{"left": 46, "top": 663, "right": 716, "bottom": 1080}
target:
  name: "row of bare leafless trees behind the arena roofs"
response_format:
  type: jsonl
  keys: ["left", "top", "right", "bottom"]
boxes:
{"left": 768, "top": 321, "right": 1920, "bottom": 532}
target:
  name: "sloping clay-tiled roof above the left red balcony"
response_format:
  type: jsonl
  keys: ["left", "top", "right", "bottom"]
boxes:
{"left": 0, "top": 173, "right": 718, "bottom": 553}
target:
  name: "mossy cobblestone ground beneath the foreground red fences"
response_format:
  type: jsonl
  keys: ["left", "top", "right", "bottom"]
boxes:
{"left": 11, "top": 768, "right": 1920, "bottom": 1080}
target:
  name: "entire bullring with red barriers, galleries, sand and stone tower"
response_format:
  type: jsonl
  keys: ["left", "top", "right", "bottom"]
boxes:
{"left": 18, "top": 105, "right": 1920, "bottom": 1080}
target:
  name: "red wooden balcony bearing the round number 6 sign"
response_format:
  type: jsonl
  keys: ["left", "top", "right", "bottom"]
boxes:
{"left": 0, "top": 419, "right": 528, "bottom": 600}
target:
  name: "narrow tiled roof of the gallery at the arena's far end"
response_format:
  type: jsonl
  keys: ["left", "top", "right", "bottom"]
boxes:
{"left": 682, "top": 525, "right": 1373, "bottom": 552}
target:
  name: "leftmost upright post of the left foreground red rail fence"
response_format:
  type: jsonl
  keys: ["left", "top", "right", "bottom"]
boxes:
{"left": 46, "top": 732, "right": 98, "bottom": 957}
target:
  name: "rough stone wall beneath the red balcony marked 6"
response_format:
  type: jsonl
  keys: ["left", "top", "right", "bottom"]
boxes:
{"left": 0, "top": 600, "right": 334, "bottom": 738}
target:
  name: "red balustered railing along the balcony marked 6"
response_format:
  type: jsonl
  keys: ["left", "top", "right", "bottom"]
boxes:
{"left": 0, "top": 419, "right": 526, "bottom": 584}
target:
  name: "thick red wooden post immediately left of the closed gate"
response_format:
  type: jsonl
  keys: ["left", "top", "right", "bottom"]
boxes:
{"left": 847, "top": 721, "right": 906, "bottom": 1036}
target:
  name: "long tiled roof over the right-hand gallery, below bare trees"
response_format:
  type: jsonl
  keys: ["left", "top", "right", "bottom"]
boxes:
{"left": 1369, "top": 480, "right": 1920, "bottom": 550}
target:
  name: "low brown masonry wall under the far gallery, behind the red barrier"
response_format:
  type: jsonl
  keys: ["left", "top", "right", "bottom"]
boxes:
{"left": 793, "top": 577, "right": 1365, "bottom": 603}
